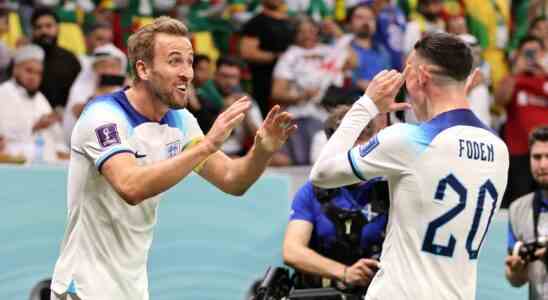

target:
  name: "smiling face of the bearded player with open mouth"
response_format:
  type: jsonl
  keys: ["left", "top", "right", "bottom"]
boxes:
{"left": 146, "top": 33, "right": 194, "bottom": 109}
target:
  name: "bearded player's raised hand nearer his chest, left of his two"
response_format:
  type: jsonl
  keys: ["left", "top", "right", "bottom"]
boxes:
{"left": 204, "top": 96, "right": 251, "bottom": 150}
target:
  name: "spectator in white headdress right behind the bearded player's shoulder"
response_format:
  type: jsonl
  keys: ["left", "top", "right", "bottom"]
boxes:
{"left": 63, "top": 44, "right": 127, "bottom": 145}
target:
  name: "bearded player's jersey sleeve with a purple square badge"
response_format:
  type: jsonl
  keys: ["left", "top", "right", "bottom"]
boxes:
{"left": 71, "top": 101, "right": 135, "bottom": 172}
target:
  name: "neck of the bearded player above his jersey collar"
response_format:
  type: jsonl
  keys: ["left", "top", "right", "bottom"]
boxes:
{"left": 125, "top": 84, "right": 169, "bottom": 122}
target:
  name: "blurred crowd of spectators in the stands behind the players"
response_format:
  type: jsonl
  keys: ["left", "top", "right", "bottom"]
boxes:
{"left": 0, "top": 0, "right": 548, "bottom": 206}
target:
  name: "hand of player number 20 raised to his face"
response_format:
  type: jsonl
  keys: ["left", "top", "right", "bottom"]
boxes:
{"left": 365, "top": 67, "right": 411, "bottom": 113}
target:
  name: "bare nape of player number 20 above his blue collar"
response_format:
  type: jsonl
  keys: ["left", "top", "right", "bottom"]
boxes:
{"left": 427, "top": 88, "right": 470, "bottom": 120}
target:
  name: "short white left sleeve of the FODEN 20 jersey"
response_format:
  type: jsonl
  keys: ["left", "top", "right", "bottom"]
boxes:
{"left": 348, "top": 124, "right": 416, "bottom": 181}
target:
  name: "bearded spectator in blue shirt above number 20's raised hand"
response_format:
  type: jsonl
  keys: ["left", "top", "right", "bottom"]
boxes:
{"left": 349, "top": 4, "right": 390, "bottom": 91}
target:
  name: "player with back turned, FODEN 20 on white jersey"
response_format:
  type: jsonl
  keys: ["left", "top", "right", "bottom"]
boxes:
{"left": 310, "top": 33, "right": 508, "bottom": 300}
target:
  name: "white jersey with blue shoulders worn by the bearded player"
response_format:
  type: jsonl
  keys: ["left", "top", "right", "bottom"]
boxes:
{"left": 52, "top": 91, "right": 203, "bottom": 300}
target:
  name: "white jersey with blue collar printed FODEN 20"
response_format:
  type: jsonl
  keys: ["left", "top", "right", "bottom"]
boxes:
{"left": 348, "top": 109, "right": 509, "bottom": 300}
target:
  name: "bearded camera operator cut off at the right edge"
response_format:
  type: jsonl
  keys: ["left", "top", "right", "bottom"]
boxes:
{"left": 506, "top": 125, "right": 548, "bottom": 300}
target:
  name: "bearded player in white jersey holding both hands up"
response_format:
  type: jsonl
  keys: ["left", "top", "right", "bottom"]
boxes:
{"left": 51, "top": 17, "right": 297, "bottom": 300}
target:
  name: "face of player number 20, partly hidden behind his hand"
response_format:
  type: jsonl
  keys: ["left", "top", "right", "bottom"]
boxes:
{"left": 405, "top": 50, "right": 427, "bottom": 121}
